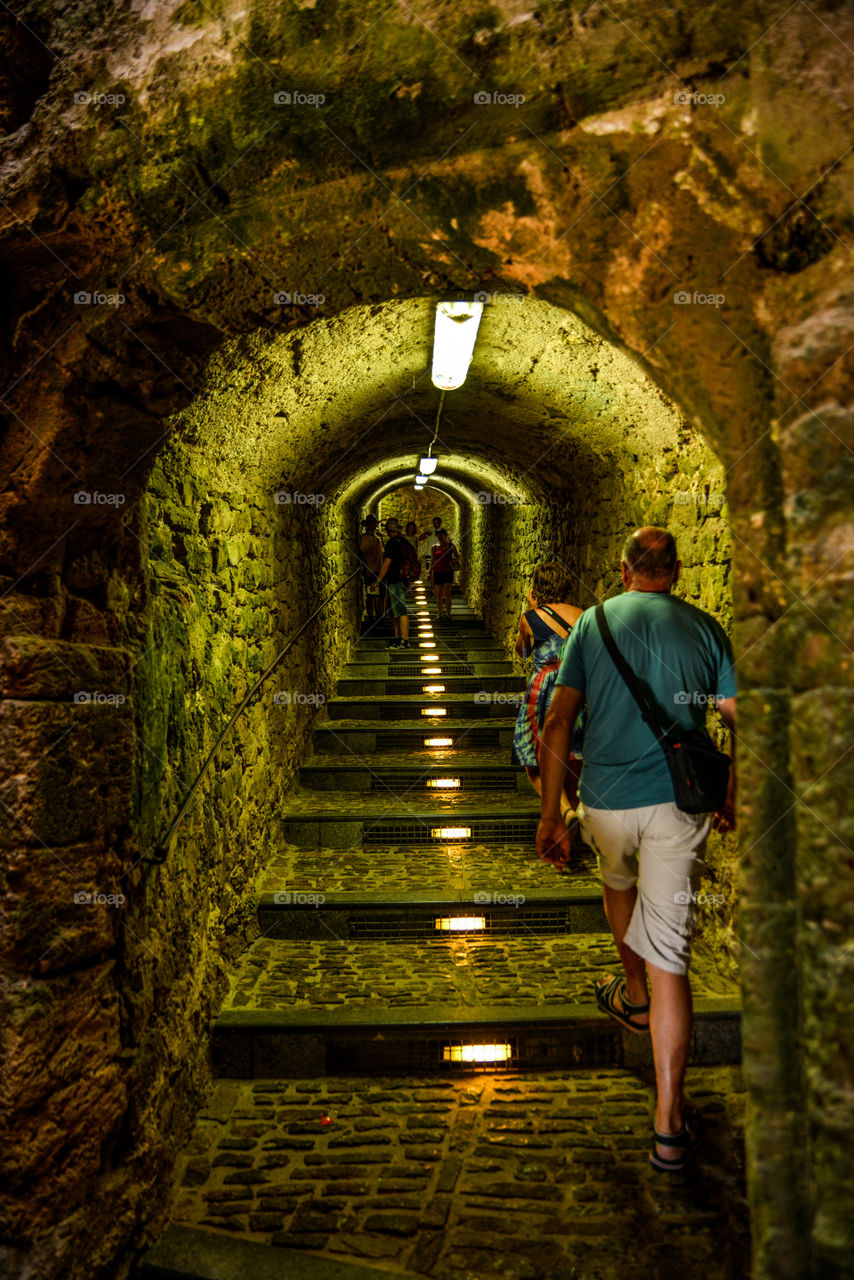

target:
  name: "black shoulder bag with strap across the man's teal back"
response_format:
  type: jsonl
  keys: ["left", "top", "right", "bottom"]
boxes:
{"left": 595, "top": 604, "right": 731, "bottom": 813}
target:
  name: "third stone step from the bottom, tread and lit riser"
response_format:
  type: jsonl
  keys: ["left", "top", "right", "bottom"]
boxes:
{"left": 280, "top": 791, "right": 539, "bottom": 856}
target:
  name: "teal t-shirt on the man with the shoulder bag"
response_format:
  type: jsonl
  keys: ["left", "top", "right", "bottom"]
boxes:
{"left": 557, "top": 591, "right": 735, "bottom": 809}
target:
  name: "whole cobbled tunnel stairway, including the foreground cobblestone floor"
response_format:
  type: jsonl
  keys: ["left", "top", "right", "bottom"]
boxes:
{"left": 136, "top": 590, "right": 748, "bottom": 1280}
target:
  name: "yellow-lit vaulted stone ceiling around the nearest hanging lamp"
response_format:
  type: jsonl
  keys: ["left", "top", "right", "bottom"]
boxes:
{"left": 175, "top": 297, "right": 693, "bottom": 499}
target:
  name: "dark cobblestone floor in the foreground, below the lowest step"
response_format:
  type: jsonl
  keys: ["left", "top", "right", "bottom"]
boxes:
{"left": 173, "top": 1068, "right": 749, "bottom": 1280}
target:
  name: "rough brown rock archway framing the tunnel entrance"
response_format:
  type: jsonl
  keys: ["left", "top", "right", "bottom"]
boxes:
{"left": 0, "top": 4, "right": 851, "bottom": 1274}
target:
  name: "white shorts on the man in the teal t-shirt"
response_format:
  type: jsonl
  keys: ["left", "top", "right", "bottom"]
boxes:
{"left": 579, "top": 801, "right": 712, "bottom": 974}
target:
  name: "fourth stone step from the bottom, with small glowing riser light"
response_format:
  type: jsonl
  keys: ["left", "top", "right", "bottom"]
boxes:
{"left": 300, "top": 753, "right": 533, "bottom": 800}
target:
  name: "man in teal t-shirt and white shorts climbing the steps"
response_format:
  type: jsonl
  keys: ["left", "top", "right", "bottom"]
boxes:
{"left": 536, "top": 526, "right": 735, "bottom": 1172}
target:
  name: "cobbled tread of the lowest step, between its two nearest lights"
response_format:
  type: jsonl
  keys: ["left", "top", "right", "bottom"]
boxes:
{"left": 224, "top": 933, "right": 737, "bottom": 1011}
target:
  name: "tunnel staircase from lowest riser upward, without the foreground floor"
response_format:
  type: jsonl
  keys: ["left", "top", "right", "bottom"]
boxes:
{"left": 214, "top": 585, "right": 739, "bottom": 1078}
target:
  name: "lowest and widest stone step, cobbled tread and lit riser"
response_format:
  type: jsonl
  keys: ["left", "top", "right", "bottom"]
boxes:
{"left": 213, "top": 933, "right": 740, "bottom": 1079}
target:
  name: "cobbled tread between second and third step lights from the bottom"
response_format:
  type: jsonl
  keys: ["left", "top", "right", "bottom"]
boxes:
{"left": 256, "top": 845, "right": 600, "bottom": 893}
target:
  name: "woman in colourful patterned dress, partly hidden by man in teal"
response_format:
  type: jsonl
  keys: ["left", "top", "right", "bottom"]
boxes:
{"left": 511, "top": 561, "right": 581, "bottom": 817}
